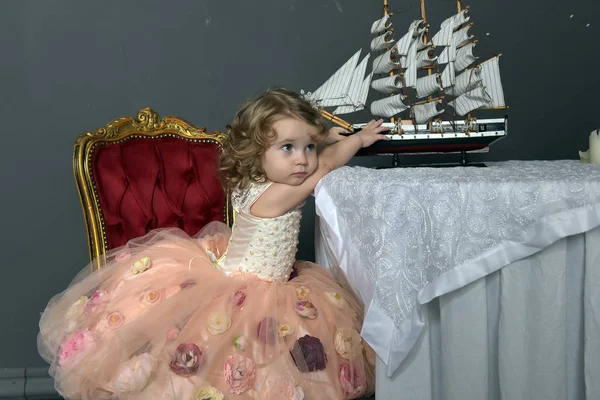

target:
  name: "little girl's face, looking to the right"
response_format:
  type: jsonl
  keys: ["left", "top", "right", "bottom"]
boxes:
{"left": 262, "top": 117, "right": 319, "bottom": 186}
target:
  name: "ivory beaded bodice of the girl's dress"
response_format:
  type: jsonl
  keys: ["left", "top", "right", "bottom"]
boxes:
{"left": 219, "top": 182, "right": 302, "bottom": 280}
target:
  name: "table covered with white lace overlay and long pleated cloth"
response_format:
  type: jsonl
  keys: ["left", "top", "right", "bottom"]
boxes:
{"left": 315, "top": 160, "right": 600, "bottom": 399}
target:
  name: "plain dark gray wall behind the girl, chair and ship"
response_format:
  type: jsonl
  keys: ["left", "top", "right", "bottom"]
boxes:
{"left": 0, "top": 0, "right": 600, "bottom": 368}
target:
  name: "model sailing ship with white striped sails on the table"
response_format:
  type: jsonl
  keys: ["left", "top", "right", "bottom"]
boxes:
{"left": 304, "top": 0, "right": 507, "bottom": 159}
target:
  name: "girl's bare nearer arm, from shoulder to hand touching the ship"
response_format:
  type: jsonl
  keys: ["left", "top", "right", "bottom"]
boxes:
{"left": 251, "top": 120, "right": 389, "bottom": 218}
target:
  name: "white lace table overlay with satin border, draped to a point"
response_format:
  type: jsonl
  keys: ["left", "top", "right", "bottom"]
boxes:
{"left": 315, "top": 161, "right": 600, "bottom": 382}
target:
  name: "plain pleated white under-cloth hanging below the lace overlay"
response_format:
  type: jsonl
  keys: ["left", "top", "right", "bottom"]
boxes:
{"left": 360, "top": 228, "right": 600, "bottom": 400}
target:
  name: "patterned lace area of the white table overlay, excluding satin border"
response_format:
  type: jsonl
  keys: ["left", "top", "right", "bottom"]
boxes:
{"left": 316, "top": 161, "right": 600, "bottom": 346}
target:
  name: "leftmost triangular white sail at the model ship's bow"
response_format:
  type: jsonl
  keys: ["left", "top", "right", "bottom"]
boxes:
{"left": 308, "top": 50, "right": 361, "bottom": 107}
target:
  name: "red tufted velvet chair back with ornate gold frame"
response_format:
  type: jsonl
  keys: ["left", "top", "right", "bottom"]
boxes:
{"left": 73, "top": 107, "right": 230, "bottom": 268}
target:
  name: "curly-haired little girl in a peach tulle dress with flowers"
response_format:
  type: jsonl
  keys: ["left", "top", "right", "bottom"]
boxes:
{"left": 38, "top": 89, "right": 386, "bottom": 400}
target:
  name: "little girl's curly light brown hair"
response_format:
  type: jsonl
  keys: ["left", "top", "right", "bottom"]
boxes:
{"left": 219, "top": 88, "right": 328, "bottom": 191}
